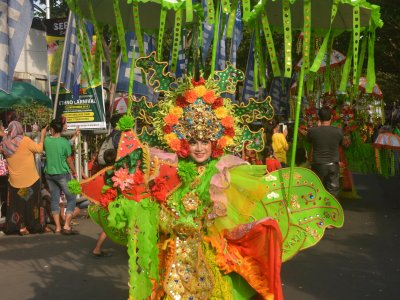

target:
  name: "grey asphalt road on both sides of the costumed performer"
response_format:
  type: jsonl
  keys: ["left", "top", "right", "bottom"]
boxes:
{"left": 0, "top": 175, "right": 400, "bottom": 300}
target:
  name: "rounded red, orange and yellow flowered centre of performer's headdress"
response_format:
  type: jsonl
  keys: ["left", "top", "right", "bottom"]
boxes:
{"left": 154, "top": 77, "right": 240, "bottom": 157}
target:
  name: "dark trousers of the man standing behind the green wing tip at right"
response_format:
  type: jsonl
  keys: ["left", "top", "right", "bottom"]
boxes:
{"left": 311, "top": 163, "right": 340, "bottom": 197}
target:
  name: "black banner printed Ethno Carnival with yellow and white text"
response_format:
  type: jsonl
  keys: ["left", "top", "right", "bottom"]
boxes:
{"left": 53, "top": 85, "right": 106, "bottom": 130}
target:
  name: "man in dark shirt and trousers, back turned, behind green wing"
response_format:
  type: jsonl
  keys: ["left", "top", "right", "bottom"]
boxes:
{"left": 307, "top": 107, "right": 343, "bottom": 197}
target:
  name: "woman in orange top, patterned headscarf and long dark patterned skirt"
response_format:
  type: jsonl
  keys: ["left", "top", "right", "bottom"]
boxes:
{"left": 0, "top": 121, "right": 49, "bottom": 235}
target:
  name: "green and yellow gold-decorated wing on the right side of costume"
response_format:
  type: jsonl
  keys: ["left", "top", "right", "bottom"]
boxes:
{"left": 215, "top": 165, "right": 344, "bottom": 261}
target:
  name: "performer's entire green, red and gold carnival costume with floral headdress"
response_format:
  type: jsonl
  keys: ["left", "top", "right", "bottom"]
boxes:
{"left": 76, "top": 54, "right": 343, "bottom": 299}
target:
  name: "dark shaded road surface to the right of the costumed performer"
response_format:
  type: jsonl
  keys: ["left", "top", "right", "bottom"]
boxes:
{"left": 282, "top": 175, "right": 400, "bottom": 300}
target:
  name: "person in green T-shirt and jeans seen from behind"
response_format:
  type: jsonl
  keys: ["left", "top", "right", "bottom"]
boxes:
{"left": 44, "top": 119, "right": 77, "bottom": 235}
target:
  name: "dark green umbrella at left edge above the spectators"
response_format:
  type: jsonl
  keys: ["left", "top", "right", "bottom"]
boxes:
{"left": 0, "top": 81, "right": 52, "bottom": 108}
